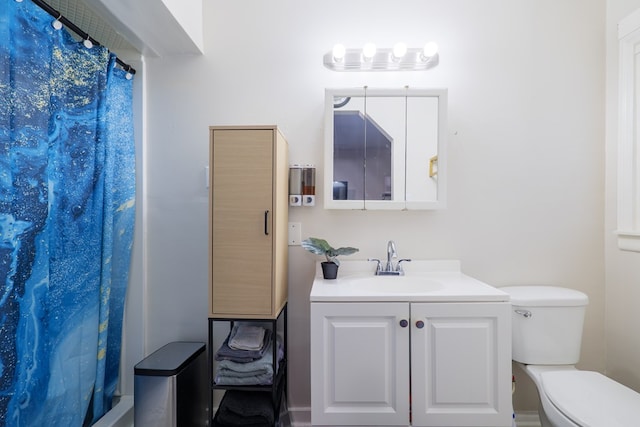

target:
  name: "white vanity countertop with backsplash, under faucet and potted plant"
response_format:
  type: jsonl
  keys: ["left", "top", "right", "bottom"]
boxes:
{"left": 309, "top": 260, "right": 509, "bottom": 302}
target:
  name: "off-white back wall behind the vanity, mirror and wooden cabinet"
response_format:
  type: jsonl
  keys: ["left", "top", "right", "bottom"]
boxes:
{"left": 138, "top": 0, "right": 605, "bottom": 410}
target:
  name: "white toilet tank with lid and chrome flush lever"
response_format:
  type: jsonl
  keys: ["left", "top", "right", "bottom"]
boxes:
{"left": 500, "top": 286, "right": 589, "bottom": 365}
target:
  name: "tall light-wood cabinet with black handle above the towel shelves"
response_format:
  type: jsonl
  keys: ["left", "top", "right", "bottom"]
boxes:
{"left": 209, "top": 126, "right": 288, "bottom": 319}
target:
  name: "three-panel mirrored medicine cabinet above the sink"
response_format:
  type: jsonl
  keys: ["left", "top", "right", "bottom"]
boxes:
{"left": 324, "top": 87, "right": 447, "bottom": 210}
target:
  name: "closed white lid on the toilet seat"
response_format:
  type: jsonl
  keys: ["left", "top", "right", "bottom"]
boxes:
{"left": 540, "top": 370, "right": 640, "bottom": 427}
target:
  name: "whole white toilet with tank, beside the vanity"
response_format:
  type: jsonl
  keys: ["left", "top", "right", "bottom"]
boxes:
{"left": 500, "top": 286, "right": 640, "bottom": 427}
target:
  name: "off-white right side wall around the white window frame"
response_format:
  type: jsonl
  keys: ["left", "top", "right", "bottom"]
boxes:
{"left": 605, "top": 0, "right": 640, "bottom": 390}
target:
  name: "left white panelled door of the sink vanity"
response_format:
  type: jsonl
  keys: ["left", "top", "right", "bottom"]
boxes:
{"left": 311, "top": 303, "right": 409, "bottom": 426}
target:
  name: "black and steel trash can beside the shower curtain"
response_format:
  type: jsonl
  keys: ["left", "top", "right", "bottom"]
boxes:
{"left": 133, "top": 342, "right": 209, "bottom": 427}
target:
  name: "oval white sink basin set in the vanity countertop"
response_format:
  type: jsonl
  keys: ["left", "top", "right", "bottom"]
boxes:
{"left": 340, "top": 275, "right": 444, "bottom": 294}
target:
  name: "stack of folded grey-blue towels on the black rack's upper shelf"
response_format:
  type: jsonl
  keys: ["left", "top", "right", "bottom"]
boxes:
{"left": 214, "top": 323, "right": 284, "bottom": 386}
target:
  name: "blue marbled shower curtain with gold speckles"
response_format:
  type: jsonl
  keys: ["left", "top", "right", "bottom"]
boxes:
{"left": 0, "top": 0, "right": 135, "bottom": 427}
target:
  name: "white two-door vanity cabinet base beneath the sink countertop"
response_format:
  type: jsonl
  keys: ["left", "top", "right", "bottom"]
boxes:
{"left": 311, "top": 302, "right": 512, "bottom": 427}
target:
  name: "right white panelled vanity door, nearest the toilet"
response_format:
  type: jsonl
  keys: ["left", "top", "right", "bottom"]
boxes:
{"left": 411, "top": 303, "right": 513, "bottom": 427}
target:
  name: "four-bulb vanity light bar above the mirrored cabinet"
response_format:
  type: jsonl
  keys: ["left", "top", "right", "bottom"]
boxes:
{"left": 323, "top": 42, "right": 439, "bottom": 71}
